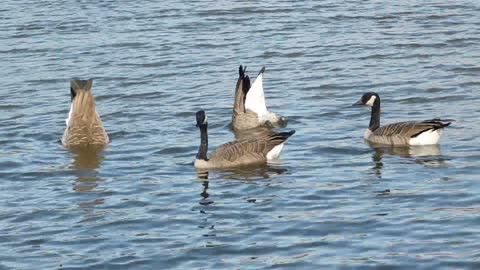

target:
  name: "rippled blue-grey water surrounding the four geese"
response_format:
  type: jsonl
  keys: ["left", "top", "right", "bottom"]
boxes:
{"left": 0, "top": 0, "right": 480, "bottom": 269}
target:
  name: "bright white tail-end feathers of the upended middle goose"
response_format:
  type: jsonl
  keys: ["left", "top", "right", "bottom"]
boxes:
{"left": 245, "top": 67, "right": 268, "bottom": 119}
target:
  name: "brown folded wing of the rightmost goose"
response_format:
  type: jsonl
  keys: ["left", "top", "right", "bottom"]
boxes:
{"left": 374, "top": 119, "right": 452, "bottom": 138}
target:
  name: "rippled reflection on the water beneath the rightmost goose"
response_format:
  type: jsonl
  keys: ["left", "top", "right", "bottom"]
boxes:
{"left": 367, "top": 143, "right": 445, "bottom": 178}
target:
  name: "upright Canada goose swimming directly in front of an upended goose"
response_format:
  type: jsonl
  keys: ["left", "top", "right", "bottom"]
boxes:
{"left": 194, "top": 111, "right": 295, "bottom": 169}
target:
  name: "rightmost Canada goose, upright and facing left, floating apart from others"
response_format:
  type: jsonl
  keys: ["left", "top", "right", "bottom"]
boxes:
{"left": 353, "top": 92, "right": 452, "bottom": 146}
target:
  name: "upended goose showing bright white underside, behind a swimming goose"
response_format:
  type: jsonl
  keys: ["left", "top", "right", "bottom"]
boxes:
{"left": 232, "top": 66, "right": 287, "bottom": 130}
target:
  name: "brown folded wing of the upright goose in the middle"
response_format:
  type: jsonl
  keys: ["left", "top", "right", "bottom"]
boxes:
{"left": 210, "top": 130, "right": 295, "bottom": 162}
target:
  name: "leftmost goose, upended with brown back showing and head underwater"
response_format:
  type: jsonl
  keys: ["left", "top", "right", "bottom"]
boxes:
{"left": 62, "top": 79, "right": 109, "bottom": 149}
